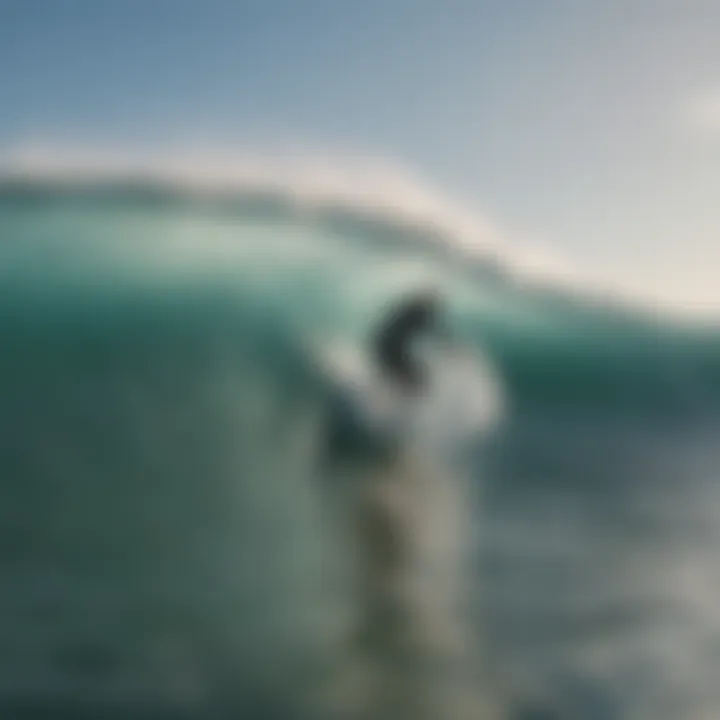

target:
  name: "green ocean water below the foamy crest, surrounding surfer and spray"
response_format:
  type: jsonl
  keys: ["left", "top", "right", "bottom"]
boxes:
{"left": 0, "top": 172, "right": 720, "bottom": 720}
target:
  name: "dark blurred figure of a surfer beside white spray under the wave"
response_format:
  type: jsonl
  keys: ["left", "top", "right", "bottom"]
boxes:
{"left": 373, "top": 295, "right": 439, "bottom": 393}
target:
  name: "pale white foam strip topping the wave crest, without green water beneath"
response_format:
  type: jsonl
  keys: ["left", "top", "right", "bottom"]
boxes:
{"left": 0, "top": 142, "right": 717, "bottom": 321}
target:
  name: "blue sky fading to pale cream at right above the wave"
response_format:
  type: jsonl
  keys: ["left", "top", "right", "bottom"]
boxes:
{"left": 0, "top": 0, "right": 720, "bottom": 313}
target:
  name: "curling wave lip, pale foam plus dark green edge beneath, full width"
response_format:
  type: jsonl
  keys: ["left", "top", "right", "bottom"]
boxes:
{"left": 0, "top": 146, "right": 717, "bottom": 331}
